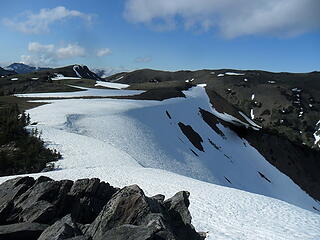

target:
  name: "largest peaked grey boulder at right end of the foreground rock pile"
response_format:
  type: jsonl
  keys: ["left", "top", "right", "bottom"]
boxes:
{"left": 86, "top": 185, "right": 201, "bottom": 240}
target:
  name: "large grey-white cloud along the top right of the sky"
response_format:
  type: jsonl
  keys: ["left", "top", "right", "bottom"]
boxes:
{"left": 124, "top": 0, "right": 320, "bottom": 38}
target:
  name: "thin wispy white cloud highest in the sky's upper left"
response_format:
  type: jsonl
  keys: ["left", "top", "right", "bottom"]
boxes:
{"left": 3, "top": 6, "right": 92, "bottom": 34}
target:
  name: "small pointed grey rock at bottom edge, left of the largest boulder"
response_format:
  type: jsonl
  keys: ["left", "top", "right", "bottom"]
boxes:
{"left": 38, "top": 215, "right": 82, "bottom": 240}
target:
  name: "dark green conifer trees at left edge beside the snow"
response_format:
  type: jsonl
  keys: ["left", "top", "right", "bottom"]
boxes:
{"left": 0, "top": 104, "right": 61, "bottom": 176}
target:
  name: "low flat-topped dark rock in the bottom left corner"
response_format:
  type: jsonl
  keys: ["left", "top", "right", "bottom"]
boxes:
{"left": 0, "top": 223, "right": 48, "bottom": 240}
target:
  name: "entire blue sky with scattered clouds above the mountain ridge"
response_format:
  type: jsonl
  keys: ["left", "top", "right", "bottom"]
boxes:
{"left": 0, "top": 0, "right": 320, "bottom": 72}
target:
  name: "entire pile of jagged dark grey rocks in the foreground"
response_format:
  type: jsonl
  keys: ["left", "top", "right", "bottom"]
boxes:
{"left": 0, "top": 177, "right": 205, "bottom": 240}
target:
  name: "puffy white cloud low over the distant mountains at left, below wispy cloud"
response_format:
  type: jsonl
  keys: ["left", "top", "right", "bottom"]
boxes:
{"left": 21, "top": 42, "right": 86, "bottom": 66}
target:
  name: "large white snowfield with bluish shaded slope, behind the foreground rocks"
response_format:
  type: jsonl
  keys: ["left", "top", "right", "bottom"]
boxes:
{"left": 0, "top": 86, "right": 320, "bottom": 240}
